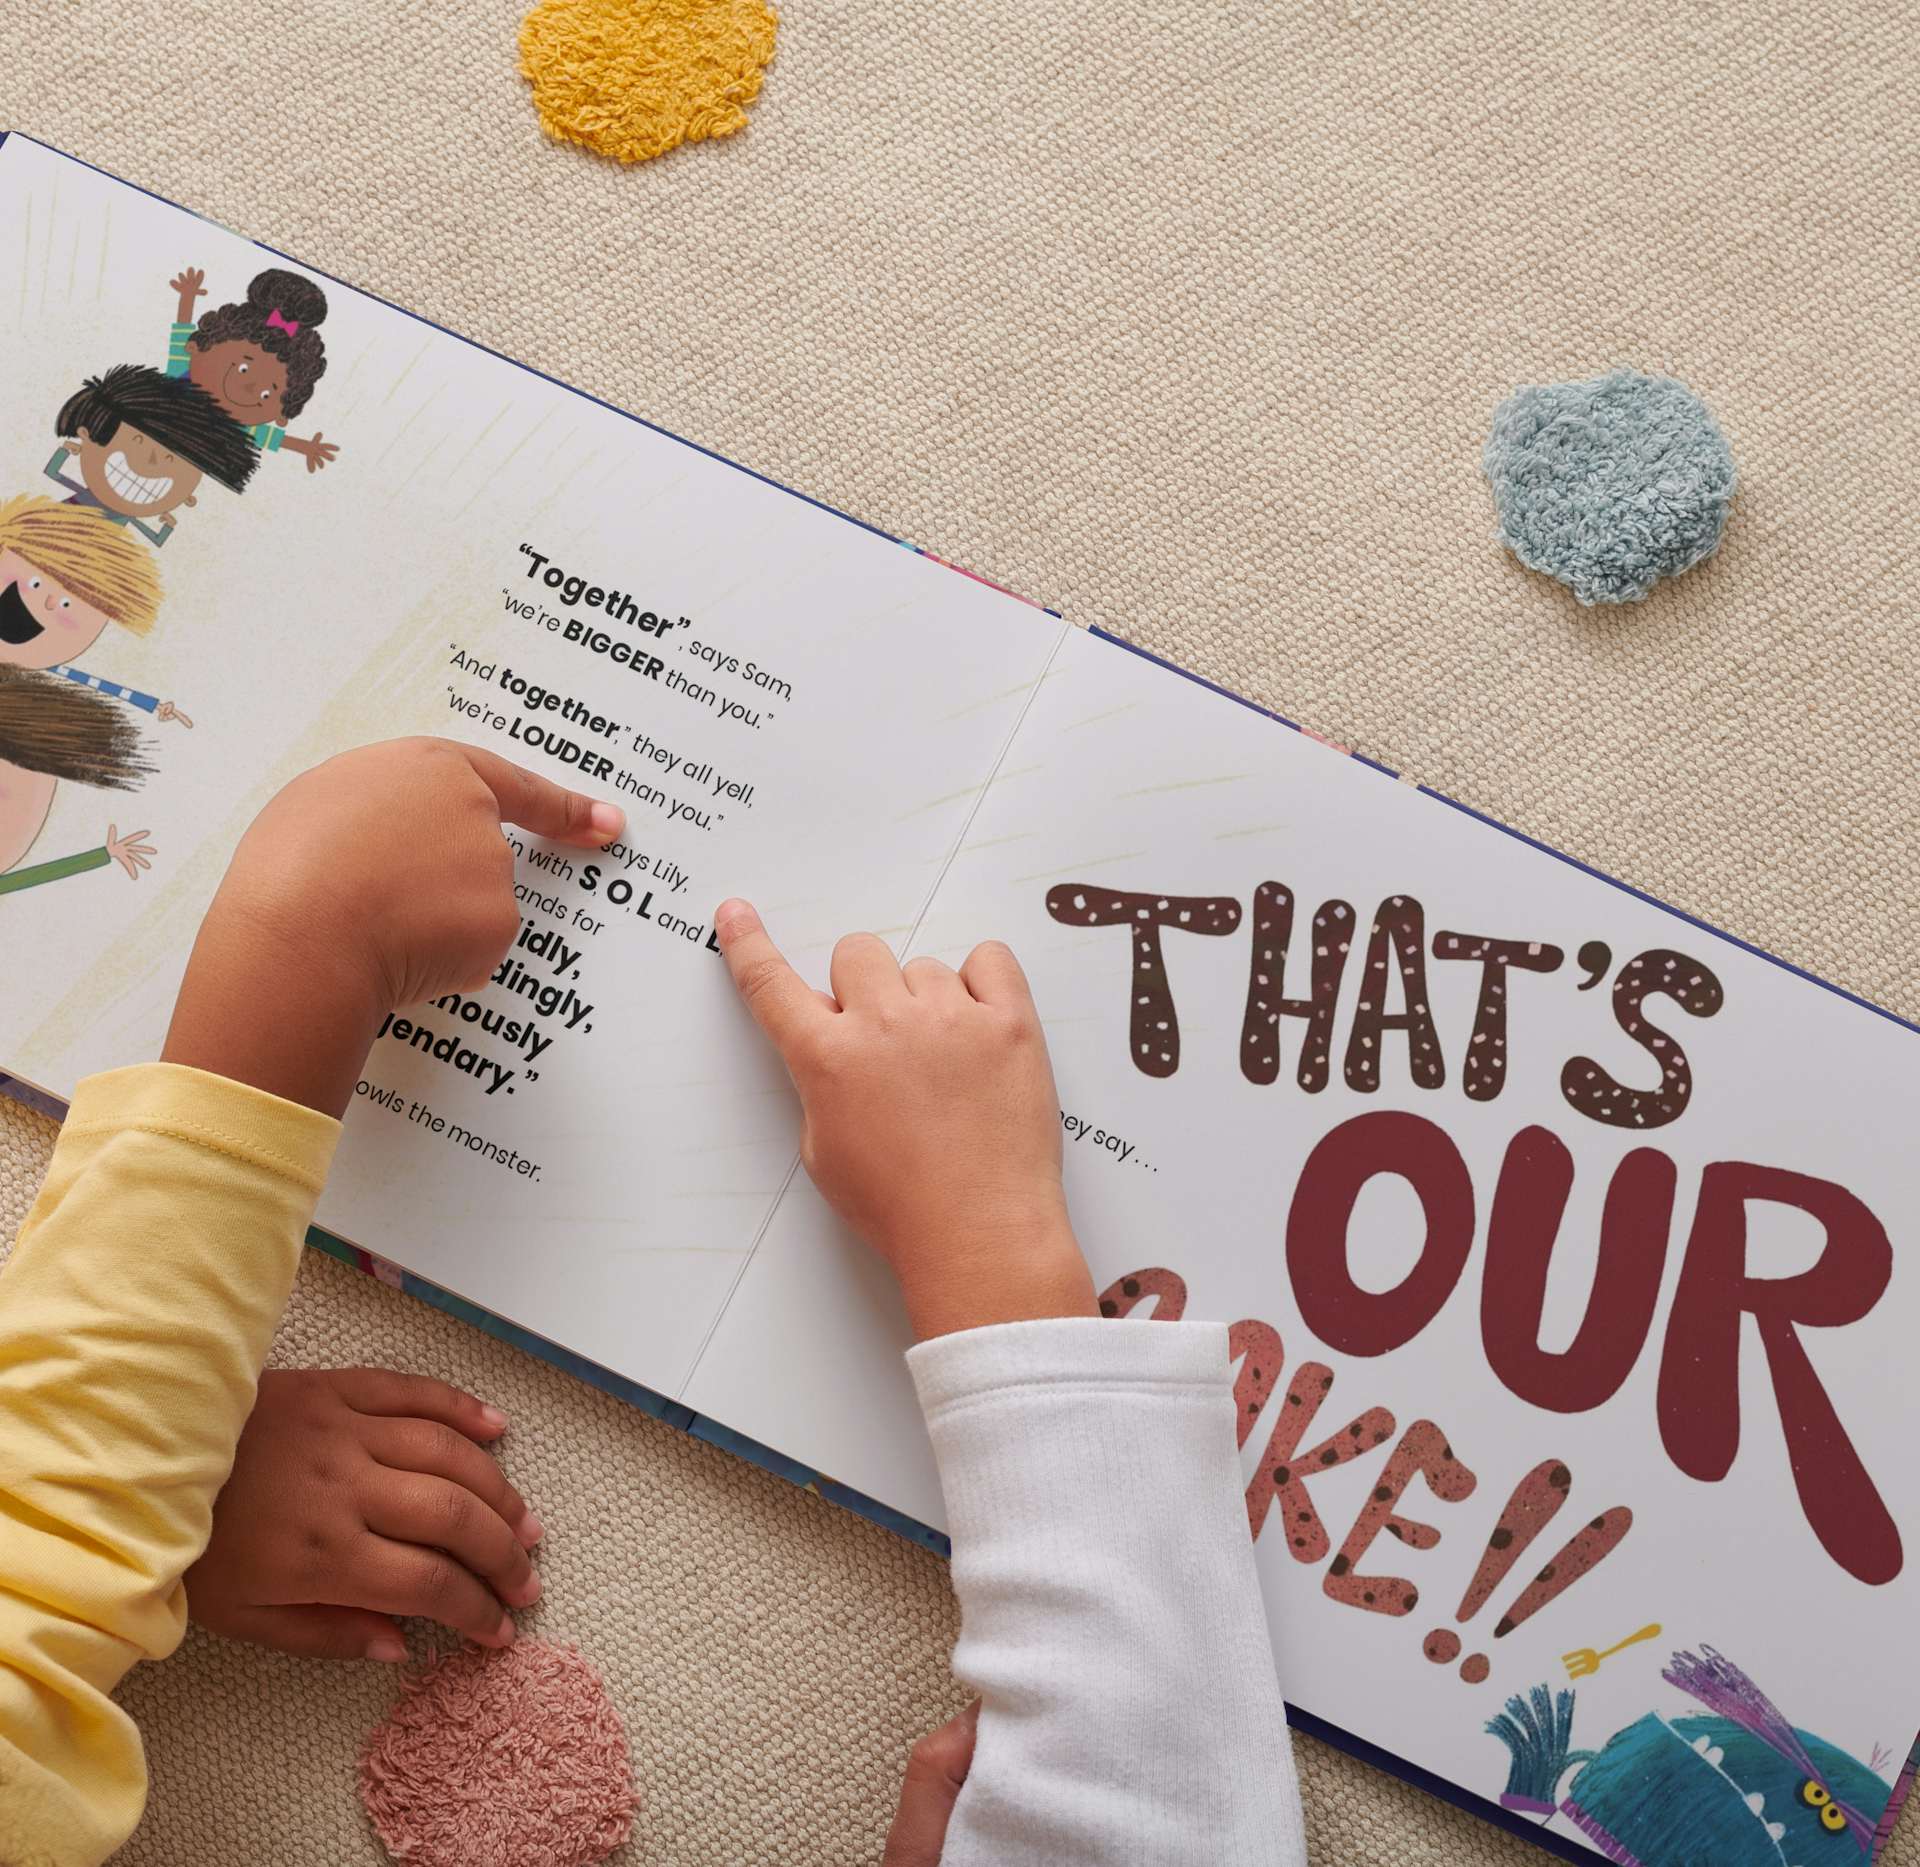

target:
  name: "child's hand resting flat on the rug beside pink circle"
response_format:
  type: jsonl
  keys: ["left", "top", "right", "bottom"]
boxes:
{"left": 186, "top": 1368, "right": 540, "bottom": 1660}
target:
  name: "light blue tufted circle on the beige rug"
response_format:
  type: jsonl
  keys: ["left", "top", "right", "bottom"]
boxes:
{"left": 1484, "top": 369, "right": 1736, "bottom": 603}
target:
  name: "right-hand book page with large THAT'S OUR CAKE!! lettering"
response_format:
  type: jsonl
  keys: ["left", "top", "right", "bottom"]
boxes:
{"left": 698, "top": 618, "right": 1920, "bottom": 1867}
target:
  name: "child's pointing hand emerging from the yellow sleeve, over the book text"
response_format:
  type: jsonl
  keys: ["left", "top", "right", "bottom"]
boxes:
{"left": 161, "top": 740, "right": 626, "bottom": 1116}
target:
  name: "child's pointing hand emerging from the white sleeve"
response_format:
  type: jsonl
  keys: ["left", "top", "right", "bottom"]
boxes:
{"left": 714, "top": 901, "right": 1094, "bottom": 1339}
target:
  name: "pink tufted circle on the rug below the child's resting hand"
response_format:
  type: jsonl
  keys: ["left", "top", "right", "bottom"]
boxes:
{"left": 359, "top": 1640, "right": 637, "bottom": 1867}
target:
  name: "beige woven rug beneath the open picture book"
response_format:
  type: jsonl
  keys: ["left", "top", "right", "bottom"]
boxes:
{"left": 0, "top": 0, "right": 1920, "bottom": 1867}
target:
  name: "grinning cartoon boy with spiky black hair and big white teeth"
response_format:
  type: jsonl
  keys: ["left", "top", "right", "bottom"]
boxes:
{"left": 46, "top": 363, "right": 259, "bottom": 546}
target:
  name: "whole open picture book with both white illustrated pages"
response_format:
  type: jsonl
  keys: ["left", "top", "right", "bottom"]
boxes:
{"left": 0, "top": 134, "right": 1920, "bottom": 1867}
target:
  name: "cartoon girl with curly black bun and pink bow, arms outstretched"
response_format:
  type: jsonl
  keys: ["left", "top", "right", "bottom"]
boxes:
{"left": 167, "top": 265, "right": 340, "bottom": 473}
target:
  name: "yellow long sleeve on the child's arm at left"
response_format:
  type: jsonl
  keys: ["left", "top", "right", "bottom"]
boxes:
{"left": 0, "top": 1064, "right": 340, "bottom": 1867}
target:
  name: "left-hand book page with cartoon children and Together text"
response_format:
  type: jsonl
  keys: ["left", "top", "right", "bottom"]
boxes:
{"left": 0, "top": 134, "right": 1064, "bottom": 1393}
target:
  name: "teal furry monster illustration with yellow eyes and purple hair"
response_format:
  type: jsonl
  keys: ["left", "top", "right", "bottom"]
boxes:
{"left": 1486, "top": 1646, "right": 1891, "bottom": 1867}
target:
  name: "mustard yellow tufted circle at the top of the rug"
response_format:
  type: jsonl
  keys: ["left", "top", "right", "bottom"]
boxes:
{"left": 520, "top": 0, "right": 778, "bottom": 161}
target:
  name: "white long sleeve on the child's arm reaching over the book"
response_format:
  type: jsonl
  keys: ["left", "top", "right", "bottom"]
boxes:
{"left": 908, "top": 1318, "right": 1306, "bottom": 1867}
